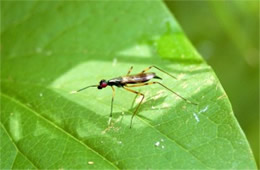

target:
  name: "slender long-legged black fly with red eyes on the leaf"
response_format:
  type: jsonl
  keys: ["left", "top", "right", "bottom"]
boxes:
{"left": 71, "top": 66, "right": 197, "bottom": 128}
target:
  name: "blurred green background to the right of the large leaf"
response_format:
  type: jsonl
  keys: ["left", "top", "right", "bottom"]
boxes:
{"left": 166, "top": 0, "right": 259, "bottom": 165}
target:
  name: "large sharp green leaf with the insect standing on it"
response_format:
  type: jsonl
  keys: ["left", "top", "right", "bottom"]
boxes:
{"left": 0, "top": 1, "right": 256, "bottom": 169}
